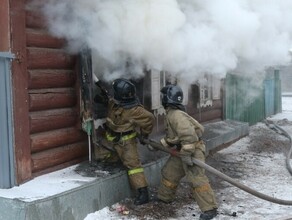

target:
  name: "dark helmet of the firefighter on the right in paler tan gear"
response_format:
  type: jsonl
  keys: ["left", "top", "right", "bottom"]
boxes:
{"left": 160, "top": 85, "right": 184, "bottom": 107}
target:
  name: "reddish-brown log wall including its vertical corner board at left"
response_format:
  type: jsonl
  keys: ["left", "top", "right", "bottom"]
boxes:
{"left": 10, "top": 0, "right": 88, "bottom": 184}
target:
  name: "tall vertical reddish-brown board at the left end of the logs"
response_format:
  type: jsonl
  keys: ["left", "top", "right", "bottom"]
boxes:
{"left": 9, "top": 1, "right": 32, "bottom": 184}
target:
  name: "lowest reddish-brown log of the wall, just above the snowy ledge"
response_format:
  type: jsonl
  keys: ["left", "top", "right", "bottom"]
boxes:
{"left": 32, "top": 141, "right": 88, "bottom": 172}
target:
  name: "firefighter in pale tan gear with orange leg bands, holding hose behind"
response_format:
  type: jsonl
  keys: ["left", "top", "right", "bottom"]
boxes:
{"left": 157, "top": 85, "right": 217, "bottom": 220}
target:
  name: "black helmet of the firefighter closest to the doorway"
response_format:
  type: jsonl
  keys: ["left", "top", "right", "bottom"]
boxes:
{"left": 112, "top": 79, "right": 136, "bottom": 103}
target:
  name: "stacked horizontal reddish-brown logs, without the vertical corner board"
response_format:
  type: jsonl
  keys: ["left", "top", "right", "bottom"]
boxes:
{"left": 26, "top": 7, "right": 88, "bottom": 178}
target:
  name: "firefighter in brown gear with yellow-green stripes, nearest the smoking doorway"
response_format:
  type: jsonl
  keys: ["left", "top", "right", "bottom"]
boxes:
{"left": 101, "top": 79, "right": 155, "bottom": 205}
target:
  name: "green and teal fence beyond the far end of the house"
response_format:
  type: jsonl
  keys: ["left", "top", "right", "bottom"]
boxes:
{"left": 224, "top": 70, "right": 282, "bottom": 125}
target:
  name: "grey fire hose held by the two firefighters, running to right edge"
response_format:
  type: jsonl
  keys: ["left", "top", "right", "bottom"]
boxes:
{"left": 143, "top": 139, "right": 292, "bottom": 205}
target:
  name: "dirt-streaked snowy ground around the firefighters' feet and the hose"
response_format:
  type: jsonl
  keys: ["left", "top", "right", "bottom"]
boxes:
{"left": 85, "top": 97, "right": 292, "bottom": 220}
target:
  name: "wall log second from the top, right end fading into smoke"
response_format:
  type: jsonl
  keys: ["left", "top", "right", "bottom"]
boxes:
{"left": 26, "top": 28, "right": 65, "bottom": 48}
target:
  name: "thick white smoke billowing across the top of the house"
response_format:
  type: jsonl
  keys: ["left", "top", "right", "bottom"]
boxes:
{"left": 28, "top": 0, "right": 292, "bottom": 82}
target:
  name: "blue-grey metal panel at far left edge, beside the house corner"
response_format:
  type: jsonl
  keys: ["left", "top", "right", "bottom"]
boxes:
{"left": 0, "top": 52, "right": 15, "bottom": 188}
